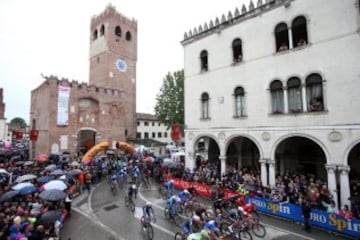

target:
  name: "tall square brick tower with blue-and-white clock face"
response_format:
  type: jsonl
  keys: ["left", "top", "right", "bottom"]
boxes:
{"left": 89, "top": 5, "right": 137, "bottom": 136}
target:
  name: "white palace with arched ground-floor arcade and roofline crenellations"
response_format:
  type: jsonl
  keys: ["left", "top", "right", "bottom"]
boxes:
{"left": 181, "top": 0, "right": 360, "bottom": 206}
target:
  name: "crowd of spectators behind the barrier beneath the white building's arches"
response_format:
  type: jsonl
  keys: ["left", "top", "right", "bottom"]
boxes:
{"left": 164, "top": 161, "right": 360, "bottom": 219}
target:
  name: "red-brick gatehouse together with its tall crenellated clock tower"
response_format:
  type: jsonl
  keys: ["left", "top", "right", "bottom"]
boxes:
{"left": 30, "top": 5, "right": 137, "bottom": 156}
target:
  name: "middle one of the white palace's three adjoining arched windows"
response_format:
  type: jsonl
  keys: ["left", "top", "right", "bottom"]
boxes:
{"left": 287, "top": 77, "right": 303, "bottom": 113}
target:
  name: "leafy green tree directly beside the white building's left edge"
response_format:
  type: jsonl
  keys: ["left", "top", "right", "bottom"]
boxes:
{"left": 155, "top": 70, "right": 184, "bottom": 129}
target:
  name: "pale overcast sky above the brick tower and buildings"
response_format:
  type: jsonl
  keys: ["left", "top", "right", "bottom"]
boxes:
{"left": 0, "top": 0, "right": 248, "bottom": 122}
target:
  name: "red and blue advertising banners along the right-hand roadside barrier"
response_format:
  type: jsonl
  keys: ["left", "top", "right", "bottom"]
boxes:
{"left": 168, "top": 177, "right": 360, "bottom": 237}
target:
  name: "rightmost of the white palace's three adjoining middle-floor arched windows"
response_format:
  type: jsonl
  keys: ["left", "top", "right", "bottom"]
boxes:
{"left": 306, "top": 73, "right": 324, "bottom": 111}
